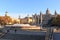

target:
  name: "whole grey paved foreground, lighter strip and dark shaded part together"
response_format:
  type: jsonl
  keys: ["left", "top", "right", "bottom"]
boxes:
{"left": 1, "top": 30, "right": 45, "bottom": 40}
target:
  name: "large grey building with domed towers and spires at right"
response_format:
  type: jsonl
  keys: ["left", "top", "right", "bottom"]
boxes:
{"left": 32, "top": 8, "right": 57, "bottom": 25}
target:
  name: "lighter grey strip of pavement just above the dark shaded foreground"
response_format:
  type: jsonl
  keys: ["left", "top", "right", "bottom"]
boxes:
{"left": 4, "top": 30, "right": 45, "bottom": 35}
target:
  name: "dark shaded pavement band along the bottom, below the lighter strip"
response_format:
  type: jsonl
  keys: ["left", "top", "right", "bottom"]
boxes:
{"left": 2, "top": 33, "right": 45, "bottom": 40}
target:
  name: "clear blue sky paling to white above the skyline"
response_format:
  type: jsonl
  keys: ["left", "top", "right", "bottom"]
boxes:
{"left": 0, "top": 0, "right": 60, "bottom": 18}
